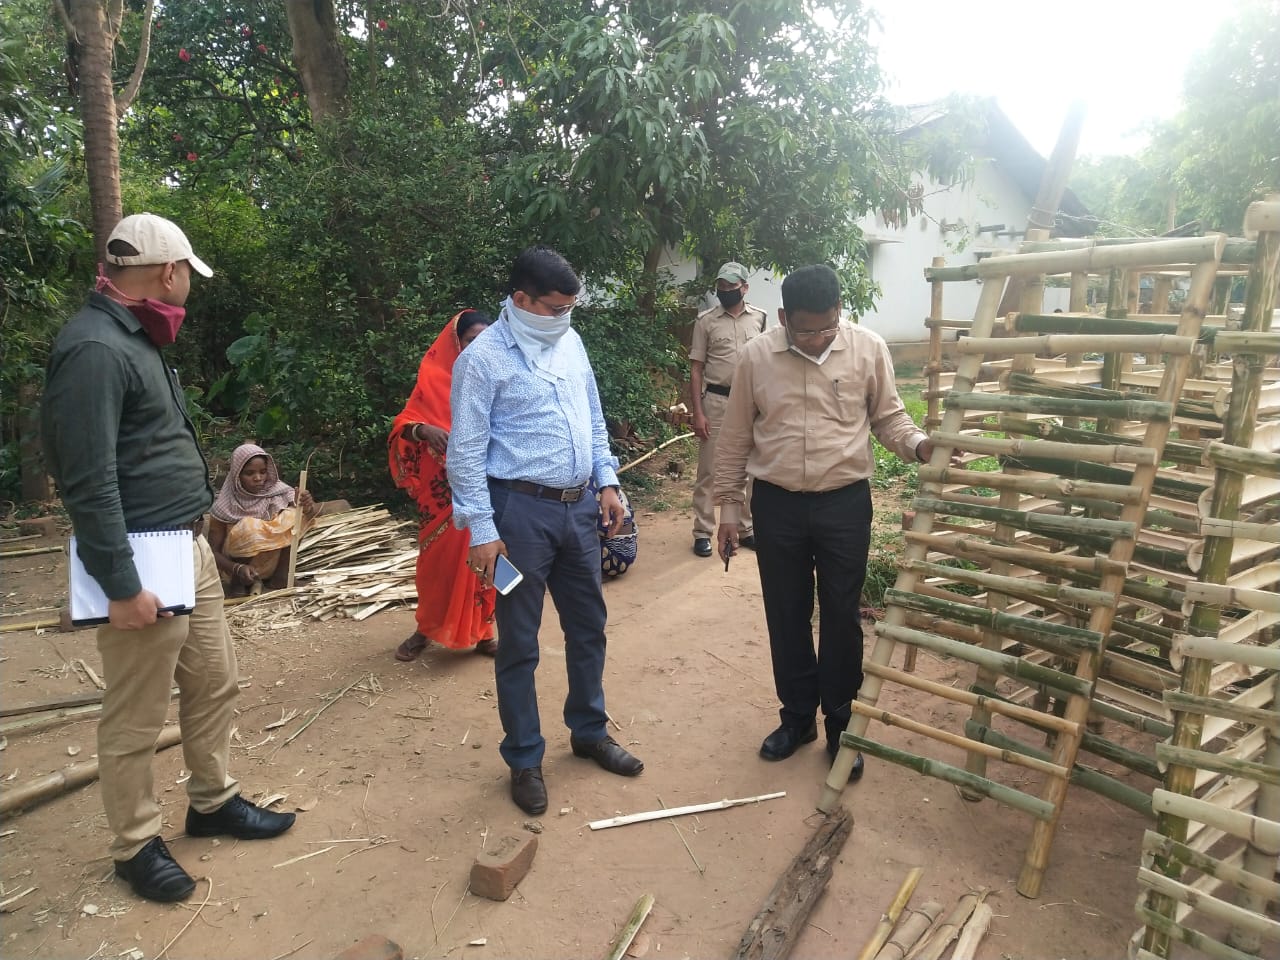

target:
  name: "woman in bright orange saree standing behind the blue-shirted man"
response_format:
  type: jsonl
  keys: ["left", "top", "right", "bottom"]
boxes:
{"left": 387, "top": 310, "right": 497, "bottom": 662}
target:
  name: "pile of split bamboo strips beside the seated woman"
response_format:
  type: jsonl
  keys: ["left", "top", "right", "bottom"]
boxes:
{"left": 227, "top": 506, "right": 417, "bottom": 630}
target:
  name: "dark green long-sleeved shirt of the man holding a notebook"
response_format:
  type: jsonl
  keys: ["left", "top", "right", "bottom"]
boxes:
{"left": 40, "top": 293, "right": 214, "bottom": 600}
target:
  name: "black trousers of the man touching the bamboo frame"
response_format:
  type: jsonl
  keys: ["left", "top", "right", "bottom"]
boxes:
{"left": 751, "top": 480, "right": 872, "bottom": 739}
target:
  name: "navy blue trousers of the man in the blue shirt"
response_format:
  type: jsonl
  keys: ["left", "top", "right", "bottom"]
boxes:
{"left": 489, "top": 484, "right": 608, "bottom": 769}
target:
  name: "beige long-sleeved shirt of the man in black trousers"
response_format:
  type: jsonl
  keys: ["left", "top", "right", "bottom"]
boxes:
{"left": 714, "top": 320, "right": 928, "bottom": 524}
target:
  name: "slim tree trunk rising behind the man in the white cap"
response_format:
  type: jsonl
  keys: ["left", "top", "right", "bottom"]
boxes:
{"left": 63, "top": 0, "right": 123, "bottom": 260}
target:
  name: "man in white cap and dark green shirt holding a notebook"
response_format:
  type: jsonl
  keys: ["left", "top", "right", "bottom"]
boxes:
{"left": 41, "top": 214, "right": 293, "bottom": 901}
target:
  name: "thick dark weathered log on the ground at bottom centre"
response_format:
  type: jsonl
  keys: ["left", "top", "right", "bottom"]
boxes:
{"left": 733, "top": 814, "right": 852, "bottom": 960}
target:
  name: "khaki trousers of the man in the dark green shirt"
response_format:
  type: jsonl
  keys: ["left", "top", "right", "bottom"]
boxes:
{"left": 97, "top": 536, "right": 239, "bottom": 860}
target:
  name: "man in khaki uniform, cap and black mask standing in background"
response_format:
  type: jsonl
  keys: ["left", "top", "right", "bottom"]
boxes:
{"left": 689, "top": 261, "right": 765, "bottom": 557}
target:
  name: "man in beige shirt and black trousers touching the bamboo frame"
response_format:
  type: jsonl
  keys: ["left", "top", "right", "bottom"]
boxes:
{"left": 714, "top": 265, "right": 933, "bottom": 780}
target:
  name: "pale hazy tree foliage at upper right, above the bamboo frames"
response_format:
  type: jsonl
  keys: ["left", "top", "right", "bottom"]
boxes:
{"left": 1073, "top": 0, "right": 1280, "bottom": 233}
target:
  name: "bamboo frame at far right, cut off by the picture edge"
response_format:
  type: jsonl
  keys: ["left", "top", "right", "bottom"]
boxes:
{"left": 1138, "top": 200, "right": 1280, "bottom": 957}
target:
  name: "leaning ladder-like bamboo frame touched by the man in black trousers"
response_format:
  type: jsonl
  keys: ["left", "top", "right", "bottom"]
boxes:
{"left": 818, "top": 237, "right": 1226, "bottom": 896}
